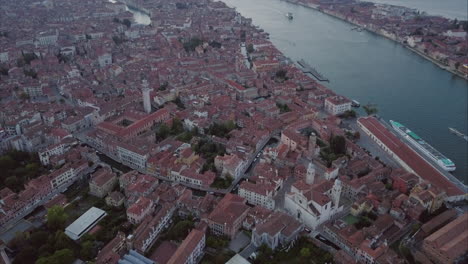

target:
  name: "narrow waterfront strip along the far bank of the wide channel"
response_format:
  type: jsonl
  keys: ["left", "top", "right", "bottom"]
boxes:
{"left": 283, "top": 0, "right": 468, "bottom": 81}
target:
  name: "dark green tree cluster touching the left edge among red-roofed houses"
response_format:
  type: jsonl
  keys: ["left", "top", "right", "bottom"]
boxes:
{"left": 0, "top": 150, "right": 46, "bottom": 192}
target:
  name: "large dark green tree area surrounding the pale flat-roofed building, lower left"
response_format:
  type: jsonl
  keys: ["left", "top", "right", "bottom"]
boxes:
{"left": 9, "top": 199, "right": 131, "bottom": 264}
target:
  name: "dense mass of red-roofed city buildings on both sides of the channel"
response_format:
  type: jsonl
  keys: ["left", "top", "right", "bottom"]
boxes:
{"left": 0, "top": 0, "right": 468, "bottom": 264}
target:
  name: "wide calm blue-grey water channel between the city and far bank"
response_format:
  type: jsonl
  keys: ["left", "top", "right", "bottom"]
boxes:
{"left": 223, "top": 0, "right": 468, "bottom": 183}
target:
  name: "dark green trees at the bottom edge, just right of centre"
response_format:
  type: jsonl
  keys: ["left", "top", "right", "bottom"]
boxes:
{"left": 253, "top": 237, "right": 333, "bottom": 264}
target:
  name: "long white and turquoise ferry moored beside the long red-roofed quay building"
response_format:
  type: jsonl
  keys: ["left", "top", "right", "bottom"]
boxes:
{"left": 390, "top": 120, "right": 456, "bottom": 171}
